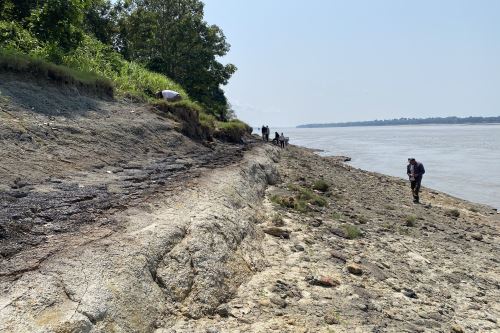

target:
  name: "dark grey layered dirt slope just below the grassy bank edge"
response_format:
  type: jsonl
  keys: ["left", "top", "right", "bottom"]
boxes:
{"left": 0, "top": 74, "right": 250, "bottom": 278}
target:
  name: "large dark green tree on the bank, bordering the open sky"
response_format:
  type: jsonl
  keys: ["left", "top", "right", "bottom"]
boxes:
{"left": 120, "top": 0, "right": 236, "bottom": 118}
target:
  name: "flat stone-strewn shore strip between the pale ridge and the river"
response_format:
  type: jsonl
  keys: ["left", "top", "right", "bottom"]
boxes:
{"left": 161, "top": 146, "right": 500, "bottom": 332}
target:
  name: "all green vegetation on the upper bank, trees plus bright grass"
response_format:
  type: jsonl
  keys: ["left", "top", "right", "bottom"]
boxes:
{"left": 0, "top": 0, "right": 243, "bottom": 135}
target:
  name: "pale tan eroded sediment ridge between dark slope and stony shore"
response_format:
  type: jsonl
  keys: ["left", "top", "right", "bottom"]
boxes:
{"left": 0, "top": 144, "right": 278, "bottom": 332}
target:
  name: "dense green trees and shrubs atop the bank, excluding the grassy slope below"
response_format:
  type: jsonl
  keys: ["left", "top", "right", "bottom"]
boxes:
{"left": 0, "top": 0, "right": 236, "bottom": 118}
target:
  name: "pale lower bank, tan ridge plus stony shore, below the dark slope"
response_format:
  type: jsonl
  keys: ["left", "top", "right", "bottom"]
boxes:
{"left": 0, "top": 133, "right": 500, "bottom": 333}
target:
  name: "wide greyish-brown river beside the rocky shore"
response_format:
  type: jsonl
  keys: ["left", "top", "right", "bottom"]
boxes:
{"left": 278, "top": 124, "right": 500, "bottom": 208}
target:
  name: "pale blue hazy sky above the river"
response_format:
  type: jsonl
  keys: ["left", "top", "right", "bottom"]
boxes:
{"left": 204, "top": 0, "right": 500, "bottom": 126}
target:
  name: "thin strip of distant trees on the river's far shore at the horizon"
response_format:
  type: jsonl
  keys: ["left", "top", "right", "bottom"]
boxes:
{"left": 297, "top": 116, "right": 500, "bottom": 128}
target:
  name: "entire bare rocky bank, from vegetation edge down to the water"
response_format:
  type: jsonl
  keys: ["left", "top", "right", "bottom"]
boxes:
{"left": 0, "top": 75, "right": 500, "bottom": 333}
